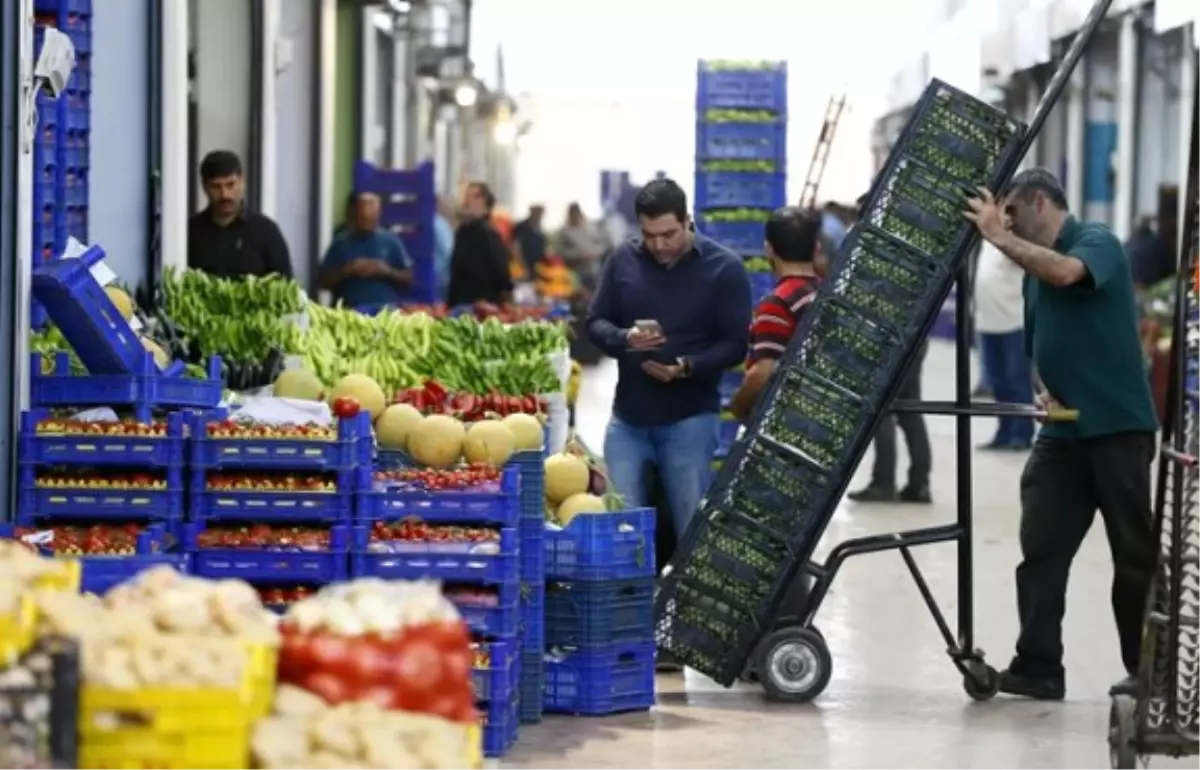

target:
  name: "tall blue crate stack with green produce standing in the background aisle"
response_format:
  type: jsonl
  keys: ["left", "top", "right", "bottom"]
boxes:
{"left": 694, "top": 60, "right": 787, "bottom": 461}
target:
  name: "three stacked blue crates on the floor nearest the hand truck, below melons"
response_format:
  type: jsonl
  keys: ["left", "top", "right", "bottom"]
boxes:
{"left": 545, "top": 509, "right": 656, "bottom": 716}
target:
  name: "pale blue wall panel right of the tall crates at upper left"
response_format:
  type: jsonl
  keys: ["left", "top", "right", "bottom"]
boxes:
{"left": 88, "top": 0, "right": 151, "bottom": 285}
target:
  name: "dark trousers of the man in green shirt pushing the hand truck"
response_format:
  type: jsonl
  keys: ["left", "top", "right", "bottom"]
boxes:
{"left": 1012, "top": 433, "right": 1158, "bottom": 676}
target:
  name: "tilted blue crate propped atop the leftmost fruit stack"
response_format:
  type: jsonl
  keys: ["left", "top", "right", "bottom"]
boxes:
{"left": 32, "top": 245, "right": 152, "bottom": 374}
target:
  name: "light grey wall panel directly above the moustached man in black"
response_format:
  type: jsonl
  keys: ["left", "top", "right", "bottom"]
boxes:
{"left": 192, "top": 0, "right": 250, "bottom": 206}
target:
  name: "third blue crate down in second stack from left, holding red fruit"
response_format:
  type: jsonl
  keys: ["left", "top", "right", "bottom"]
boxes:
{"left": 184, "top": 522, "right": 349, "bottom": 584}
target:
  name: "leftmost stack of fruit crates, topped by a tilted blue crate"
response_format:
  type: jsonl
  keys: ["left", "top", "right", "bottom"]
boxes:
{"left": 14, "top": 247, "right": 222, "bottom": 592}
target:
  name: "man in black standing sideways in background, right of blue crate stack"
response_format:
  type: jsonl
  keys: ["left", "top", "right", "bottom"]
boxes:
{"left": 446, "top": 182, "right": 512, "bottom": 307}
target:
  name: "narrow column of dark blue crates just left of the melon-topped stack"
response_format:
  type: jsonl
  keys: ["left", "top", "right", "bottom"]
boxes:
{"left": 512, "top": 451, "right": 546, "bottom": 724}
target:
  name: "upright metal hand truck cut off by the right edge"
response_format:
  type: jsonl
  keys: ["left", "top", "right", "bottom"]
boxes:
{"left": 1109, "top": 38, "right": 1200, "bottom": 770}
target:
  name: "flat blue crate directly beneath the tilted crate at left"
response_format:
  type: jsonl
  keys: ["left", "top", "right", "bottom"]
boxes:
{"left": 29, "top": 352, "right": 223, "bottom": 422}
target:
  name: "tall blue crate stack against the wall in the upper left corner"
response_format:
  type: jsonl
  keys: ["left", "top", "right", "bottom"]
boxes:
{"left": 31, "top": 0, "right": 91, "bottom": 329}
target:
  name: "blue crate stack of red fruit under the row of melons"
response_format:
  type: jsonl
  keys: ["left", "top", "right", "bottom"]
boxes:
{"left": 350, "top": 455, "right": 522, "bottom": 757}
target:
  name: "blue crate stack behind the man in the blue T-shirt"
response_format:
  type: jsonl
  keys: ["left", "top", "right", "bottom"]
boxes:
{"left": 354, "top": 161, "right": 438, "bottom": 304}
